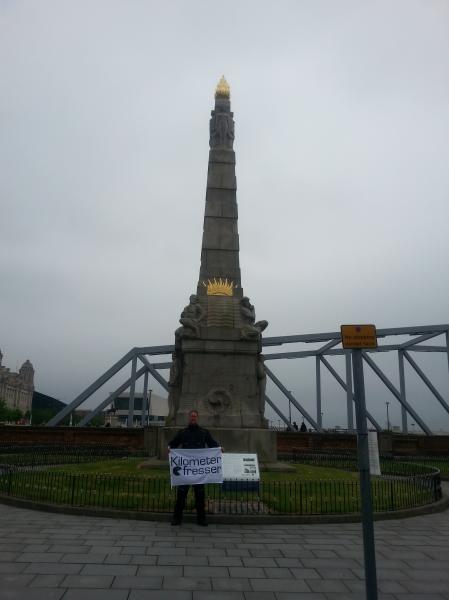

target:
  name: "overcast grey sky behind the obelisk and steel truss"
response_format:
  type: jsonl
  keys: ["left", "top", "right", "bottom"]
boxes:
{"left": 0, "top": 0, "right": 449, "bottom": 429}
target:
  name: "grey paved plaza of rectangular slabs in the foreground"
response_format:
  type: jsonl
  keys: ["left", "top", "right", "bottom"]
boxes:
{"left": 0, "top": 505, "right": 449, "bottom": 600}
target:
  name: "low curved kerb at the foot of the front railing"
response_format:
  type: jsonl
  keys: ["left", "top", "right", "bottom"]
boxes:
{"left": 0, "top": 483, "right": 449, "bottom": 525}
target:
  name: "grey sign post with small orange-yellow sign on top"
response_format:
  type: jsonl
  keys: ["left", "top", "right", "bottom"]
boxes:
{"left": 341, "top": 325, "right": 377, "bottom": 600}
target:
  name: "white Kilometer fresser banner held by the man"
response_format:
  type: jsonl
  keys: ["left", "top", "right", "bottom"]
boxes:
{"left": 168, "top": 448, "right": 223, "bottom": 486}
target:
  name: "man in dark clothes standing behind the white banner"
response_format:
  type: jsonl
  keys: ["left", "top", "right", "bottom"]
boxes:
{"left": 168, "top": 410, "right": 219, "bottom": 527}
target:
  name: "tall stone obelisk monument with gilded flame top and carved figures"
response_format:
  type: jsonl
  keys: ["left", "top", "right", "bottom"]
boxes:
{"left": 160, "top": 77, "right": 276, "bottom": 462}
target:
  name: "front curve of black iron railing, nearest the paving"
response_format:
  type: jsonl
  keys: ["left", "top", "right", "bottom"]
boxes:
{"left": 0, "top": 468, "right": 441, "bottom": 515}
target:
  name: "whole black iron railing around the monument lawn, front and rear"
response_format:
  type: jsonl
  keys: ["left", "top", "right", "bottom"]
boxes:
{"left": 0, "top": 444, "right": 441, "bottom": 515}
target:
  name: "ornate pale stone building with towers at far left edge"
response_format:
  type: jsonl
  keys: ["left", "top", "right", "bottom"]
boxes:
{"left": 0, "top": 350, "right": 34, "bottom": 414}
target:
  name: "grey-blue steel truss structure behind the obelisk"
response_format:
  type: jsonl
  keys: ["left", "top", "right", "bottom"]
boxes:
{"left": 47, "top": 325, "right": 449, "bottom": 435}
